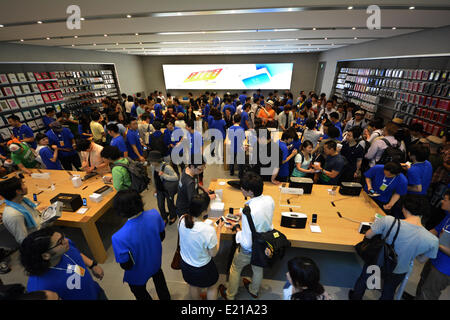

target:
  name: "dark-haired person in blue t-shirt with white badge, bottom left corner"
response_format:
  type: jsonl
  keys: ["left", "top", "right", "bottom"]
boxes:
{"left": 20, "top": 227, "right": 107, "bottom": 300}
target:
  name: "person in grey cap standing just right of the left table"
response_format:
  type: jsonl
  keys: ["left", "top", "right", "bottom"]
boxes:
{"left": 148, "top": 151, "right": 178, "bottom": 225}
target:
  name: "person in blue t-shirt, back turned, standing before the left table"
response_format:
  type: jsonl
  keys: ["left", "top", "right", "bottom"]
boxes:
{"left": 112, "top": 190, "right": 170, "bottom": 300}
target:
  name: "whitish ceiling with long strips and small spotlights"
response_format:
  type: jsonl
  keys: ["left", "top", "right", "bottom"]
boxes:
{"left": 0, "top": 0, "right": 450, "bottom": 55}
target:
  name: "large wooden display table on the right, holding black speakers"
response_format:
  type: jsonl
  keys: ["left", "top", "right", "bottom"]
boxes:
{"left": 209, "top": 179, "right": 384, "bottom": 252}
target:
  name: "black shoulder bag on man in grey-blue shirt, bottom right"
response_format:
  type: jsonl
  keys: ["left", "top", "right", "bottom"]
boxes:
{"left": 355, "top": 219, "right": 400, "bottom": 275}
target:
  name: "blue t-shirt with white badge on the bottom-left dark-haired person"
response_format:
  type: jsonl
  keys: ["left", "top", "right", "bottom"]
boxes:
{"left": 27, "top": 240, "right": 100, "bottom": 300}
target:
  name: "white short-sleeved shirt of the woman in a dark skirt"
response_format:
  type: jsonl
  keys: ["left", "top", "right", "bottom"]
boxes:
{"left": 179, "top": 219, "right": 217, "bottom": 268}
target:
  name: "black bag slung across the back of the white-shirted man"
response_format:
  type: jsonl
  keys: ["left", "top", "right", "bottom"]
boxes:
{"left": 242, "top": 205, "right": 291, "bottom": 268}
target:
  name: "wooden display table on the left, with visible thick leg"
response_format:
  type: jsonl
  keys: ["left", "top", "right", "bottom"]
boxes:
{"left": 2, "top": 169, "right": 116, "bottom": 263}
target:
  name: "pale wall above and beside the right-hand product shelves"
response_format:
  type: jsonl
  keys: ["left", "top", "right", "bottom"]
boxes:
{"left": 319, "top": 26, "right": 450, "bottom": 96}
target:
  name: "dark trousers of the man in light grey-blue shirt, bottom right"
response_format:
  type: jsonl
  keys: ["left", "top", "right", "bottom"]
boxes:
{"left": 349, "top": 264, "right": 406, "bottom": 300}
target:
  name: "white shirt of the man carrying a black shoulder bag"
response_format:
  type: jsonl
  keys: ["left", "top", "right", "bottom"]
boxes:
{"left": 236, "top": 195, "right": 275, "bottom": 252}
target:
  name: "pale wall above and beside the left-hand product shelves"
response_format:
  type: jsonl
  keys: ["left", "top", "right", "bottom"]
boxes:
{"left": 0, "top": 43, "right": 145, "bottom": 94}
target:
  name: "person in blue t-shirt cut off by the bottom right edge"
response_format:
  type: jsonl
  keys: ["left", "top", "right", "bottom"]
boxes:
{"left": 416, "top": 190, "right": 450, "bottom": 300}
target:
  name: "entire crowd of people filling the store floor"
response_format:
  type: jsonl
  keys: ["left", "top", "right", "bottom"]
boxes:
{"left": 0, "top": 90, "right": 450, "bottom": 300}
